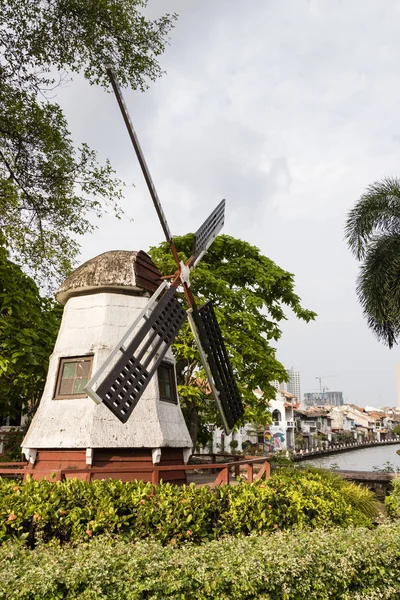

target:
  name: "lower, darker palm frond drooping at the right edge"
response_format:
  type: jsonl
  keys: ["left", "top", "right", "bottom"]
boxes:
{"left": 357, "top": 233, "right": 400, "bottom": 348}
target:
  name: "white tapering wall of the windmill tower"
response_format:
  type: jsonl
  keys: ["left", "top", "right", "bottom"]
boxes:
{"left": 22, "top": 292, "right": 192, "bottom": 449}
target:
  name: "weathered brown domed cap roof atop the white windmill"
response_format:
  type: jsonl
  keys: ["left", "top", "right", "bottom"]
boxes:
{"left": 56, "top": 250, "right": 161, "bottom": 304}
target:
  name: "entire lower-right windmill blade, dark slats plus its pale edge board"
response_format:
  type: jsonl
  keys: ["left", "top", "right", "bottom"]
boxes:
{"left": 187, "top": 302, "right": 244, "bottom": 435}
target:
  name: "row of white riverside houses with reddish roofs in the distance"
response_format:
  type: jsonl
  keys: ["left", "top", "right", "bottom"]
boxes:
{"left": 212, "top": 390, "right": 400, "bottom": 452}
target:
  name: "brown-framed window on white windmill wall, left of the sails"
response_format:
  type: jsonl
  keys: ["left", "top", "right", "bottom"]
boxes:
{"left": 54, "top": 356, "right": 93, "bottom": 400}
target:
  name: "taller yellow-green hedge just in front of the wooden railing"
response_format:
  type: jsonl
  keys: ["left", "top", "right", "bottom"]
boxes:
{"left": 0, "top": 468, "right": 378, "bottom": 547}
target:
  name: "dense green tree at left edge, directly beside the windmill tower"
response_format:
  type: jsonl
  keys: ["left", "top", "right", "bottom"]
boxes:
{"left": 0, "top": 246, "right": 61, "bottom": 416}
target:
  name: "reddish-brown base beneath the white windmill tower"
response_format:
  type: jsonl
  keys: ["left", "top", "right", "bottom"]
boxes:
{"left": 26, "top": 448, "right": 187, "bottom": 484}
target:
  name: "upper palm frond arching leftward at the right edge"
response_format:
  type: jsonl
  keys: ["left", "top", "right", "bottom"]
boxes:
{"left": 345, "top": 177, "right": 400, "bottom": 260}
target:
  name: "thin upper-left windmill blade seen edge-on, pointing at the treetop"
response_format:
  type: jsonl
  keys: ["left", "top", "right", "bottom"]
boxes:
{"left": 107, "top": 68, "right": 172, "bottom": 243}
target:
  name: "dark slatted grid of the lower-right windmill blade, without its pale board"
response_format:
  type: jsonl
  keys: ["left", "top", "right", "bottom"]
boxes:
{"left": 192, "top": 302, "right": 244, "bottom": 429}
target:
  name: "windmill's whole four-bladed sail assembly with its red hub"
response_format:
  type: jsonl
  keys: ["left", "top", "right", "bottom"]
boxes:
{"left": 86, "top": 68, "right": 244, "bottom": 435}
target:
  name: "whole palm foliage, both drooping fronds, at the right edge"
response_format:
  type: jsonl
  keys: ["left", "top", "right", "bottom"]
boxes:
{"left": 345, "top": 177, "right": 400, "bottom": 348}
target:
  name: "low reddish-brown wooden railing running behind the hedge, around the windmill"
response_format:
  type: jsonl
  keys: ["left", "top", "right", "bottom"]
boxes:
{"left": 0, "top": 457, "right": 271, "bottom": 487}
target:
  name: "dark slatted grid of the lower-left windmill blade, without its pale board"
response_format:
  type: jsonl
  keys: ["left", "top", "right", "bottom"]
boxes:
{"left": 96, "top": 287, "right": 186, "bottom": 423}
